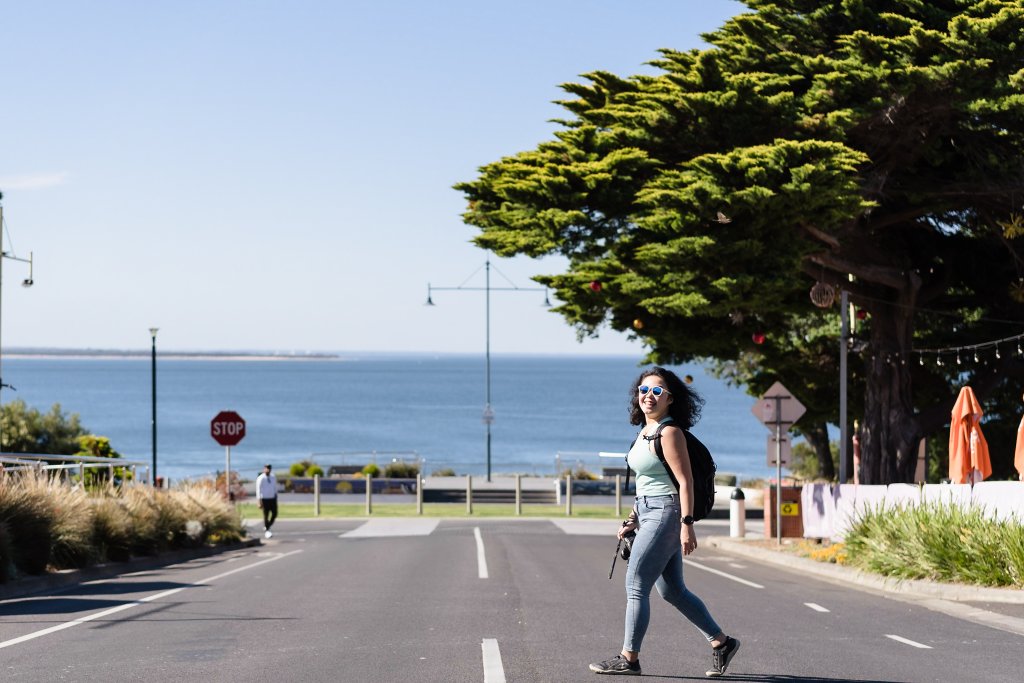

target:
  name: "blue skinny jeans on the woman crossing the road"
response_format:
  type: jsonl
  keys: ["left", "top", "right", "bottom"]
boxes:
{"left": 623, "top": 496, "right": 722, "bottom": 652}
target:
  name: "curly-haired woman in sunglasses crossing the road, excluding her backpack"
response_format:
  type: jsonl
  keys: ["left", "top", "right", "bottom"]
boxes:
{"left": 590, "top": 368, "right": 739, "bottom": 677}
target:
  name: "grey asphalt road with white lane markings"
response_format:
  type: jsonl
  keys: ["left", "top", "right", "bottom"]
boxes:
{"left": 0, "top": 518, "right": 1024, "bottom": 683}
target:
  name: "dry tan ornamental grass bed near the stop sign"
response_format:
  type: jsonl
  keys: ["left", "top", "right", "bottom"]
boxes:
{"left": 0, "top": 470, "right": 245, "bottom": 583}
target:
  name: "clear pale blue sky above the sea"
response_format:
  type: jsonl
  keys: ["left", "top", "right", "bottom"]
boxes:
{"left": 0, "top": 0, "right": 743, "bottom": 354}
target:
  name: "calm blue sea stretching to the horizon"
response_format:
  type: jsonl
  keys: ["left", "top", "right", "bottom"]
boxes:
{"left": 3, "top": 354, "right": 774, "bottom": 479}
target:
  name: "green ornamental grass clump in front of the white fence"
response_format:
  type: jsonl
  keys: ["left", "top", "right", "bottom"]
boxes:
{"left": 846, "top": 503, "right": 1024, "bottom": 588}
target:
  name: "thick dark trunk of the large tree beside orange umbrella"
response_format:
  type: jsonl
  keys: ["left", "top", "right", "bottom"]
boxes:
{"left": 860, "top": 292, "right": 922, "bottom": 484}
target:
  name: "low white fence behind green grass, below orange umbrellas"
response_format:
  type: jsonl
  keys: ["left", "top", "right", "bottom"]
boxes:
{"left": 800, "top": 481, "right": 1024, "bottom": 541}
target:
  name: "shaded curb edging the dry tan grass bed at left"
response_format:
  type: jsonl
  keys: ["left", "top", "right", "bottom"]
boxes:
{"left": 0, "top": 539, "right": 261, "bottom": 600}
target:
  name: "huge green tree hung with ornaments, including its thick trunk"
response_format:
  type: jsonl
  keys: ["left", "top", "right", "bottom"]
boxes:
{"left": 456, "top": 0, "right": 1024, "bottom": 483}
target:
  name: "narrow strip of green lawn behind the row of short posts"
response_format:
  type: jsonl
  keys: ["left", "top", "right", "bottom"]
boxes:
{"left": 239, "top": 503, "right": 629, "bottom": 519}
